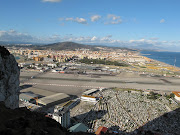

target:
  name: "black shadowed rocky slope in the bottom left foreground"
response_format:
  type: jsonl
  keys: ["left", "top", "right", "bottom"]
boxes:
{"left": 0, "top": 102, "right": 93, "bottom": 135}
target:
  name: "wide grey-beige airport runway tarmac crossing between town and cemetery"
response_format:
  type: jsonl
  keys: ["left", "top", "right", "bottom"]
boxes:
{"left": 20, "top": 73, "right": 180, "bottom": 96}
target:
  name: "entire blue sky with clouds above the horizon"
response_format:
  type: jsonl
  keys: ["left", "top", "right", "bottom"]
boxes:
{"left": 0, "top": 0, "right": 180, "bottom": 51}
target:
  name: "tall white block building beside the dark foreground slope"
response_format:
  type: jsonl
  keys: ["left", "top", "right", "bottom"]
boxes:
{"left": 52, "top": 108, "right": 70, "bottom": 128}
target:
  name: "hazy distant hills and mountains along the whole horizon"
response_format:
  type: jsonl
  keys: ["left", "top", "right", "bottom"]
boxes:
{"left": 0, "top": 41, "right": 180, "bottom": 52}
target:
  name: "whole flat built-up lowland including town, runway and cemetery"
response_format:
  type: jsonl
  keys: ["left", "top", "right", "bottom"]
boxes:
{"left": 5, "top": 43, "right": 180, "bottom": 135}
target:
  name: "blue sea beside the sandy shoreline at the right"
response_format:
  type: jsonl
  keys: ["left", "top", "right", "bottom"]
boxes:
{"left": 140, "top": 51, "right": 180, "bottom": 67}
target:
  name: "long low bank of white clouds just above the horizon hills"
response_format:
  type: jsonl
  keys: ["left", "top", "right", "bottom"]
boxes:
{"left": 0, "top": 30, "right": 180, "bottom": 51}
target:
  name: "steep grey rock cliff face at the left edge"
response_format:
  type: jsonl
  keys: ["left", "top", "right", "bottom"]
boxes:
{"left": 0, "top": 46, "right": 20, "bottom": 109}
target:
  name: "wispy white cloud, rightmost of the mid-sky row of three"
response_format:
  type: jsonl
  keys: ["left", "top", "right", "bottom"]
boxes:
{"left": 105, "top": 14, "right": 122, "bottom": 24}
